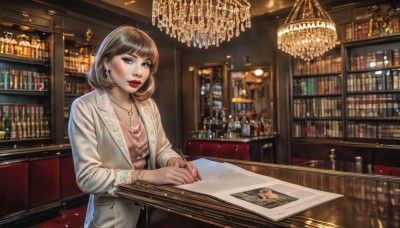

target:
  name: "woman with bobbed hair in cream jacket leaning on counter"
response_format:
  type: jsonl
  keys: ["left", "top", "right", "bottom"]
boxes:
{"left": 68, "top": 26, "right": 202, "bottom": 227}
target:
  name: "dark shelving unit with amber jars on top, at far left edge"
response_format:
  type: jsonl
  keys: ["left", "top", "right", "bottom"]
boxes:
{"left": 0, "top": 17, "right": 54, "bottom": 147}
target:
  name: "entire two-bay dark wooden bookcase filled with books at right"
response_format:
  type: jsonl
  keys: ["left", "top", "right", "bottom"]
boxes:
{"left": 291, "top": 3, "right": 400, "bottom": 146}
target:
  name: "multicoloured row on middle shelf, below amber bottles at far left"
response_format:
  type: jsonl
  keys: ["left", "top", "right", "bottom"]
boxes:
{"left": 0, "top": 68, "right": 50, "bottom": 91}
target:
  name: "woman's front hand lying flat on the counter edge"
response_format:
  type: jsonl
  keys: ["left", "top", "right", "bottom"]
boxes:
{"left": 143, "top": 164, "right": 194, "bottom": 185}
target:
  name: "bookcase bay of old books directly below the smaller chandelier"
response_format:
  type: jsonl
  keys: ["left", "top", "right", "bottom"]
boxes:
{"left": 292, "top": 48, "right": 343, "bottom": 139}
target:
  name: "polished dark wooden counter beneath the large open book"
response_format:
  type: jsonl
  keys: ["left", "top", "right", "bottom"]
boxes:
{"left": 118, "top": 159, "right": 400, "bottom": 227}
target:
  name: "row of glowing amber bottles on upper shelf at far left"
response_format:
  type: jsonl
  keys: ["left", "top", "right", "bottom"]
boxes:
{"left": 0, "top": 32, "right": 49, "bottom": 60}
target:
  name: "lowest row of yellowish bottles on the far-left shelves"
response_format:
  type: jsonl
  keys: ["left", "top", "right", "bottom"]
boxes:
{"left": 0, "top": 104, "right": 50, "bottom": 140}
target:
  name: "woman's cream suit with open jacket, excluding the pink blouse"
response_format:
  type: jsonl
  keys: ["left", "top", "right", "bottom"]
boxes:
{"left": 68, "top": 89, "right": 179, "bottom": 227}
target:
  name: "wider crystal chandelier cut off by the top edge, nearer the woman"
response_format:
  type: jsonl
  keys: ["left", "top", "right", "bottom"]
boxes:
{"left": 152, "top": 0, "right": 251, "bottom": 48}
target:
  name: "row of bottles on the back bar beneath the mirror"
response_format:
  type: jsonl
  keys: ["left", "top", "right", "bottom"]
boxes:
{"left": 199, "top": 111, "right": 273, "bottom": 139}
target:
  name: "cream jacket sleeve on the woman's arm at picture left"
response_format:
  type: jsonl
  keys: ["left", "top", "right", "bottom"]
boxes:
{"left": 68, "top": 93, "right": 132, "bottom": 195}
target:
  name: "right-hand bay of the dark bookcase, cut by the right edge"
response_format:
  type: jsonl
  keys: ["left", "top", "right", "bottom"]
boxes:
{"left": 344, "top": 34, "right": 400, "bottom": 142}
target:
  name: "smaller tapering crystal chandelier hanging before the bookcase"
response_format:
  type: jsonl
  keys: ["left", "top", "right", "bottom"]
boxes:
{"left": 278, "top": 0, "right": 337, "bottom": 61}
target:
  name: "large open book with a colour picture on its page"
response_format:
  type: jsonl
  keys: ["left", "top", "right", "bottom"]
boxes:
{"left": 176, "top": 158, "right": 342, "bottom": 221}
